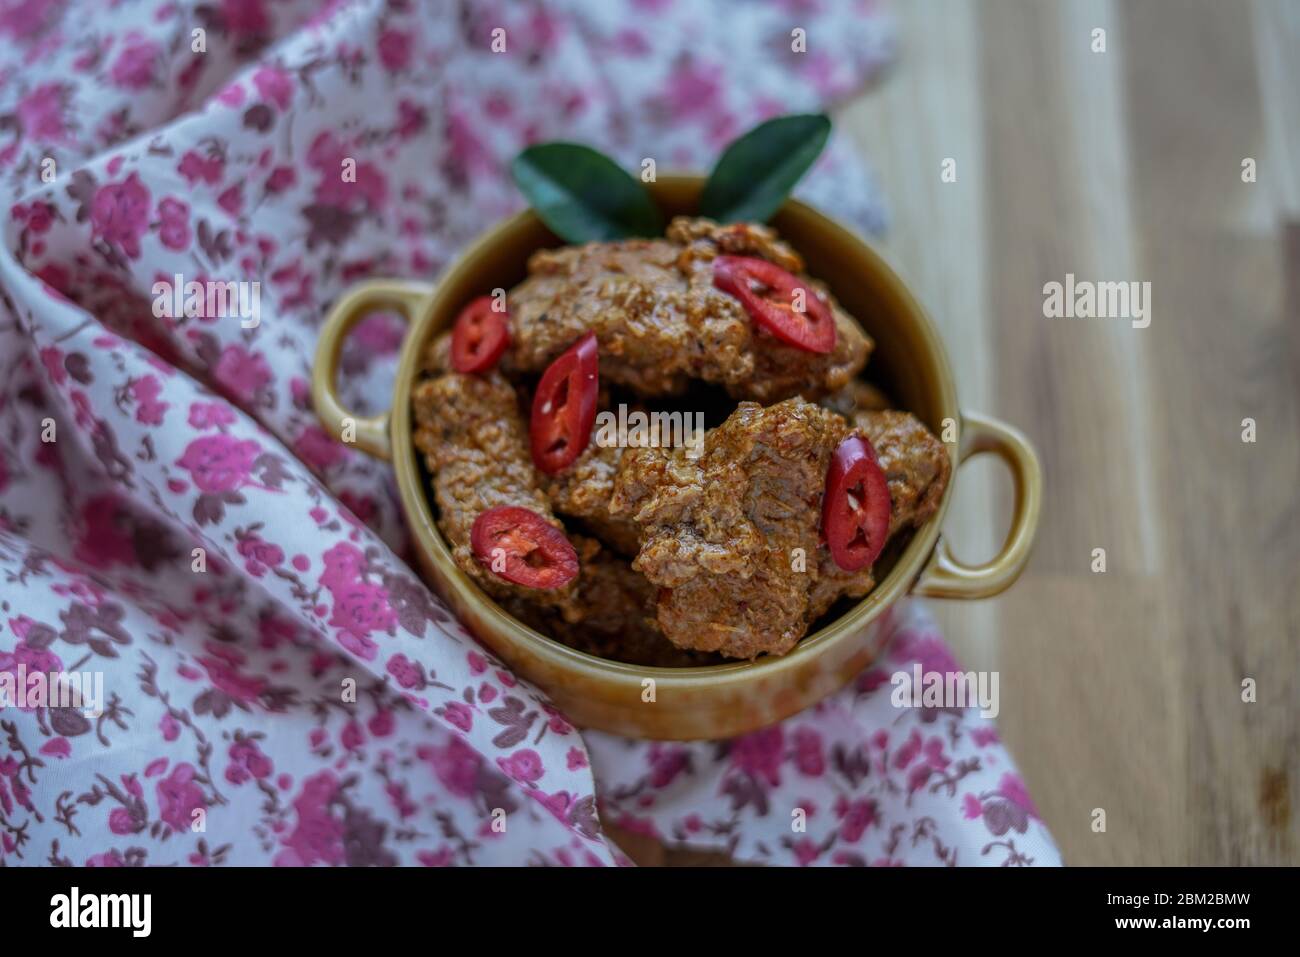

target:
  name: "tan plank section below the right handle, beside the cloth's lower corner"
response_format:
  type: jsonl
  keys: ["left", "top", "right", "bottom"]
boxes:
{"left": 998, "top": 575, "right": 1190, "bottom": 866}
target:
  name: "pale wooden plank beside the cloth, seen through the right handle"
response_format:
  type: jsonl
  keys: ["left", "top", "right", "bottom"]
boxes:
{"left": 836, "top": 0, "right": 1010, "bottom": 670}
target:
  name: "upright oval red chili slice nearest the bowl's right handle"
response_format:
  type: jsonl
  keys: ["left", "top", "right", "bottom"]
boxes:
{"left": 822, "top": 436, "right": 889, "bottom": 572}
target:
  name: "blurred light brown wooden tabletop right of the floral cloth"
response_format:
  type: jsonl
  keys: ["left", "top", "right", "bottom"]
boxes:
{"left": 611, "top": 0, "right": 1300, "bottom": 865}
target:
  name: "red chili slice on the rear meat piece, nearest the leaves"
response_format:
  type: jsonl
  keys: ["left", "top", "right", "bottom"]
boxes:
{"left": 714, "top": 256, "right": 835, "bottom": 355}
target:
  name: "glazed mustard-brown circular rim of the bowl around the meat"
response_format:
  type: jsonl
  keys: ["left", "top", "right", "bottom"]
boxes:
{"left": 389, "top": 176, "right": 962, "bottom": 688}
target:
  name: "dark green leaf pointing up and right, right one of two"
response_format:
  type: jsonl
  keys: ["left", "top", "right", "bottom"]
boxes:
{"left": 699, "top": 113, "right": 831, "bottom": 222}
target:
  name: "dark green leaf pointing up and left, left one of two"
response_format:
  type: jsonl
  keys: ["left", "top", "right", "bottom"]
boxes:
{"left": 511, "top": 143, "right": 663, "bottom": 243}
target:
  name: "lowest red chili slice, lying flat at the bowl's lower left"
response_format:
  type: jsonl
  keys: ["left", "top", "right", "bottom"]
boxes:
{"left": 469, "top": 506, "right": 577, "bottom": 589}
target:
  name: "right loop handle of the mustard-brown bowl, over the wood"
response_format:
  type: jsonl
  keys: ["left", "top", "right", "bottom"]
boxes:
{"left": 913, "top": 412, "right": 1043, "bottom": 598}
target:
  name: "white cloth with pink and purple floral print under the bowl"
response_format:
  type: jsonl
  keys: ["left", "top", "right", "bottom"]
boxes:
{"left": 0, "top": 0, "right": 1057, "bottom": 866}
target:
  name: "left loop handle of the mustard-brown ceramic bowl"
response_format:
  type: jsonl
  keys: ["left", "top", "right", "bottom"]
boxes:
{"left": 312, "top": 280, "right": 433, "bottom": 459}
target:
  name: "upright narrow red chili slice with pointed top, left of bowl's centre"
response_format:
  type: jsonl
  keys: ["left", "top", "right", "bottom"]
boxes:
{"left": 528, "top": 333, "right": 601, "bottom": 475}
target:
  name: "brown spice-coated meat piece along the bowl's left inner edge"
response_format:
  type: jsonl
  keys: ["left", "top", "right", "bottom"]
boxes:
{"left": 411, "top": 372, "right": 582, "bottom": 620}
